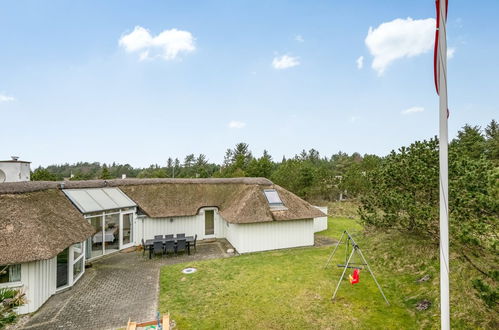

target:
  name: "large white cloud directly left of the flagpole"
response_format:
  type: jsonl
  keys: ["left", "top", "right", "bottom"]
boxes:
{"left": 365, "top": 17, "right": 435, "bottom": 75}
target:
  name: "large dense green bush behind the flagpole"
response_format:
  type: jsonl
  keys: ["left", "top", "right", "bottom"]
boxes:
{"left": 360, "top": 138, "right": 499, "bottom": 251}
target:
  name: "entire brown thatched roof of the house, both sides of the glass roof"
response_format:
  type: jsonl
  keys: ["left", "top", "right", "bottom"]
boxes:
{"left": 0, "top": 178, "right": 324, "bottom": 265}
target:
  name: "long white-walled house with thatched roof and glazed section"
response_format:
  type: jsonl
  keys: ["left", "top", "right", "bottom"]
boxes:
{"left": 0, "top": 178, "right": 327, "bottom": 313}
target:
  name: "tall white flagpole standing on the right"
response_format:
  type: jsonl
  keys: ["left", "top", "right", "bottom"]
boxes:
{"left": 437, "top": 0, "right": 450, "bottom": 330}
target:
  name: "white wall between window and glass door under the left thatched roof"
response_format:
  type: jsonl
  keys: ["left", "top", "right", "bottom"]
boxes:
{"left": 19, "top": 257, "right": 57, "bottom": 314}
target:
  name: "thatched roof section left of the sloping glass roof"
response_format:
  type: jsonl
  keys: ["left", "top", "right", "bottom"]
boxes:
{"left": 0, "top": 189, "right": 95, "bottom": 265}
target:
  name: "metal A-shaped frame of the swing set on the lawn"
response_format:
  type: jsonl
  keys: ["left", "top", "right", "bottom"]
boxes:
{"left": 324, "top": 230, "right": 390, "bottom": 305}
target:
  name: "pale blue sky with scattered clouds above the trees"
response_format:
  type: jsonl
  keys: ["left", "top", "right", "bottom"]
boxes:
{"left": 0, "top": 0, "right": 499, "bottom": 166}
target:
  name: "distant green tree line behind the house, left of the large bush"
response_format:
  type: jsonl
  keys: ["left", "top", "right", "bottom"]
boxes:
{"left": 31, "top": 143, "right": 380, "bottom": 201}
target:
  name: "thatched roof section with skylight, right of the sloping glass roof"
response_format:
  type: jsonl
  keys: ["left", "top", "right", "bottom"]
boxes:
{"left": 120, "top": 178, "right": 324, "bottom": 223}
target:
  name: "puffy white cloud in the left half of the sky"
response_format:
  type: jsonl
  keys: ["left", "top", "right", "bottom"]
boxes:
{"left": 118, "top": 26, "right": 196, "bottom": 61}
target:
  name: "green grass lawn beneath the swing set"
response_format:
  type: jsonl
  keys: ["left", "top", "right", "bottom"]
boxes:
{"left": 159, "top": 218, "right": 498, "bottom": 329}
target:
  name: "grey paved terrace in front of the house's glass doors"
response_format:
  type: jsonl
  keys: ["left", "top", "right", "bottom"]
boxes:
{"left": 16, "top": 240, "right": 234, "bottom": 330}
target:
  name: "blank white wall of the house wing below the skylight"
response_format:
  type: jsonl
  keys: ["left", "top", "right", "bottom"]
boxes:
{"left": 227, "top": 219, "right": 314, "bottom": 253}
